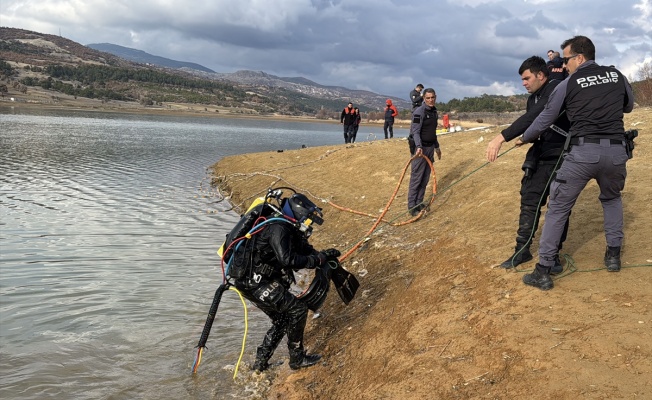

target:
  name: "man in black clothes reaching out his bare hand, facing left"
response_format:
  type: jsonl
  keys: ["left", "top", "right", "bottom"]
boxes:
{"left": 486, "top": 56, "right": 570, "bottom": 275}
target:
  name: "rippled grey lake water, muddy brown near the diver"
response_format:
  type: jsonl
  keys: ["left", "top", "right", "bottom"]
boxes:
{"left": 0, "top": 107, "right": 407, "bottom": 399}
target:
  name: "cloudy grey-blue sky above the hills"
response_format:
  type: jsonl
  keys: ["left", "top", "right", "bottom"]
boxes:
{"left": 0, "top": 0, "right": 652, "bottom": 101}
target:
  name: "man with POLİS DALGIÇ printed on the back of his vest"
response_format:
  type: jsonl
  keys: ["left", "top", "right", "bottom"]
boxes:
{"left": 517, "top": 36, "right": 634, "bottom": 290}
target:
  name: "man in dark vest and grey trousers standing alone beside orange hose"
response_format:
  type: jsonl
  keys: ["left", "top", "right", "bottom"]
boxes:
{"left": 408, "top": 88, "right": 441, "bottom": 216}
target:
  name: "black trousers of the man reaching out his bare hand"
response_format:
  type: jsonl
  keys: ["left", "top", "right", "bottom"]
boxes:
{"left": 516, "top": 161, "right": 568, "bottom": 250}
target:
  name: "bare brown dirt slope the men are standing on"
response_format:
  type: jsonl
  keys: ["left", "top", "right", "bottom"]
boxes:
{"left": 215, "top": 108, "right": 652, "bottom": 399}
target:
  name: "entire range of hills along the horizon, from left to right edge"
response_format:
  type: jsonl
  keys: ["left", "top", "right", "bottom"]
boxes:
{"left": 0, "top": 28, "right": 652, "bottom": 119}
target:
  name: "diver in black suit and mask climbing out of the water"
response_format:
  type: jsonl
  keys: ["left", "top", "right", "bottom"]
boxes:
{"left": 230, "top": 193, "right": 340, "bottom": 371}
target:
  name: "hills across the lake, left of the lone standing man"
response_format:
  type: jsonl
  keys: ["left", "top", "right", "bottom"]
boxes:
{"left": 0, "top": 28, "right": 408, "bottom": 115}
